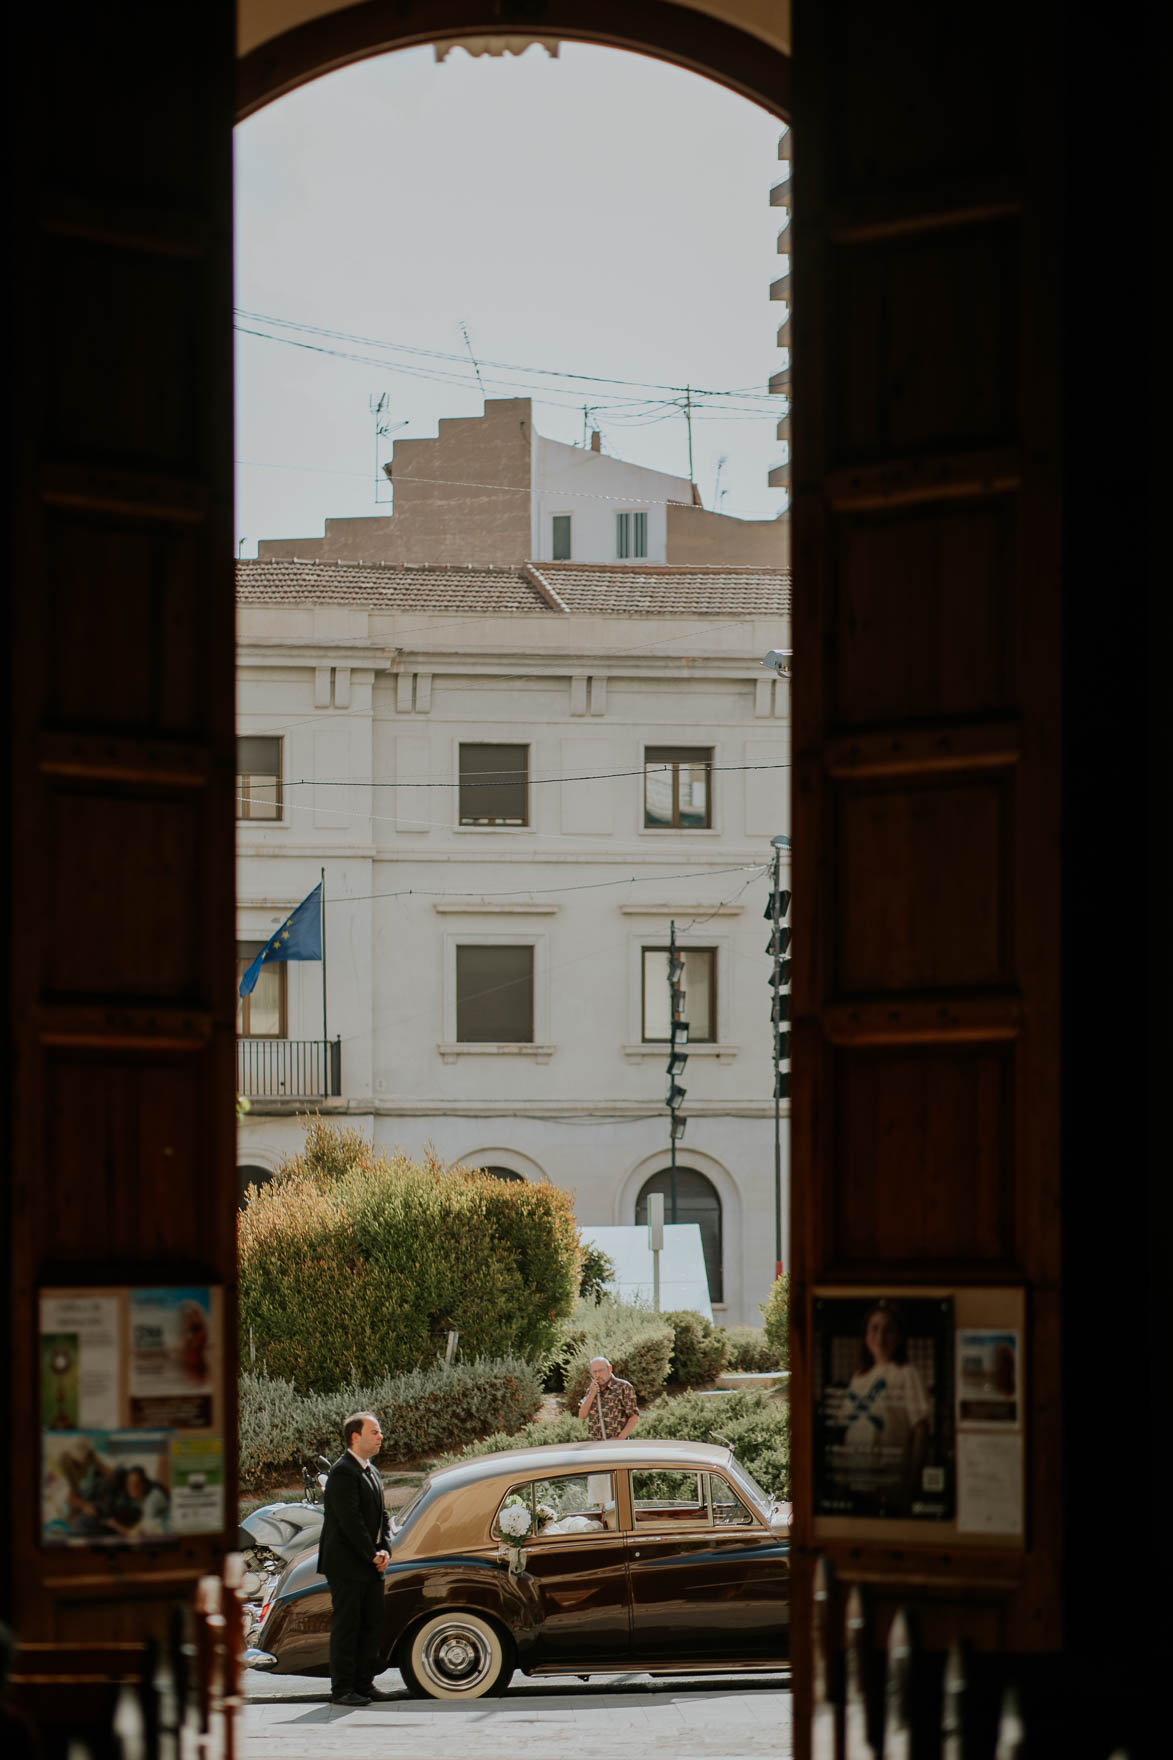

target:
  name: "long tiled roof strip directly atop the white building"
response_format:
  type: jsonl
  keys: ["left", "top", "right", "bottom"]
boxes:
{"left": 236, "top": 560, "right": 791, "bottom": 618}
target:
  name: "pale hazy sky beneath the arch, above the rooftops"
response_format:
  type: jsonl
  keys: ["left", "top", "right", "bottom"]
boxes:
{"left": 236, "top": 44, "right": 784, "bottom": 556}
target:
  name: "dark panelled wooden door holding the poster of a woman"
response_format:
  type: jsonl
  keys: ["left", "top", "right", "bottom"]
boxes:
{"left": 791, "top": 0, "right": 1064, "bottom": 1751}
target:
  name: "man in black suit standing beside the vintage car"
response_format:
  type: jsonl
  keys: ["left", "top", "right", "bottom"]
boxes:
{"left": 317, "top": 1412, "right": 391, "bottom": 1705}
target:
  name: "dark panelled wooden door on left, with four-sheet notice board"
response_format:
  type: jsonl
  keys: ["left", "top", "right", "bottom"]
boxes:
{"left": 4, "top": 0, "right": 236, "bottom": 1647}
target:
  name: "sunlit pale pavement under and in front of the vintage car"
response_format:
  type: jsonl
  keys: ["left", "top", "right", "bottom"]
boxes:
{"left": 238, "top": 1670, "right": 793, "bottom": 1760}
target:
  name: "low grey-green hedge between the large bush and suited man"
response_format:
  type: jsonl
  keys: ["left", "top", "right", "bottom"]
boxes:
{"left": 240, "top": 1357, "right": 542, "bottom": 1485}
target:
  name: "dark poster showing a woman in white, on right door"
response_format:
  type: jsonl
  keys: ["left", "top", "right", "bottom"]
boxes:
{"left": 812, "top": 1292, "right": 955, "bottom": 1521}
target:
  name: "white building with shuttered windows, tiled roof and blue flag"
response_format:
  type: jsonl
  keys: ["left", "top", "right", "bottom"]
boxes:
{"left": 238, "top": 561, "right": 791, "bottom": 1324}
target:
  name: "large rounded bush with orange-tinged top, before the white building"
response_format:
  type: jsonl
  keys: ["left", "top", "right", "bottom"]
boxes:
{"left": 240, "top": 1119, "right": 581, "bottom": 1392}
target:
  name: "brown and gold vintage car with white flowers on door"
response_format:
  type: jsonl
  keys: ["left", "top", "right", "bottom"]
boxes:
{"left": 247, "top": 1441, "right": 791, "bottom": 1698}
